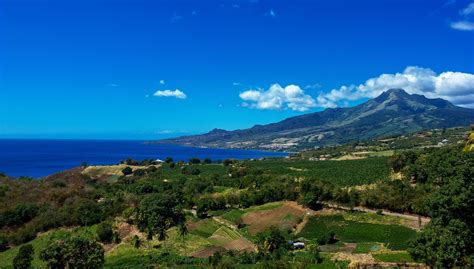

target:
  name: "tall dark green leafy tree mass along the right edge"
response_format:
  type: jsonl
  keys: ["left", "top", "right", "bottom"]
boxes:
{"left": 409, "top": 149, "right": 474, "bottom": 268}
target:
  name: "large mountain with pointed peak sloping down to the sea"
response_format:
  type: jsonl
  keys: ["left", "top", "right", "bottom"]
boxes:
{"left": 154, "top": 89, "right": 474, "bottom": 150}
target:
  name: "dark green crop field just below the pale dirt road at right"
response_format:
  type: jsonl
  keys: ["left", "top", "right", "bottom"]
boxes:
{"left": 299, "top": 215, "right": 416, "bottom": 250}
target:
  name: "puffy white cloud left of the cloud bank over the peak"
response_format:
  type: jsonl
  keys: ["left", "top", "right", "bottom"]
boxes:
{"left": 239, "top": 84, "right": 316, "bottom": 111}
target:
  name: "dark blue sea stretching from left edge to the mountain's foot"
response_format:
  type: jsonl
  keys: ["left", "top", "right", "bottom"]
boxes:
{"left": 0, "top": 139, "right": 287, "bottom": 178}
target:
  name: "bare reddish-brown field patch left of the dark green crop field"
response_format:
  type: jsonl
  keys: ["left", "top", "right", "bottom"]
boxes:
{"left": 242, "top": 201, "right": 307, "bottom": 235}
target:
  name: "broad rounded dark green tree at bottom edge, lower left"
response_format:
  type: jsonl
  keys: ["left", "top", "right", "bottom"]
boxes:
{"left": 40, "top": 236, "right": 105, "bottom": 269}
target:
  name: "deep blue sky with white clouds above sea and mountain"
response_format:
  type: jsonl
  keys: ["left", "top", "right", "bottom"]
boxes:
{"left": 0, "top": 0, "right": 474, "bottom": 139}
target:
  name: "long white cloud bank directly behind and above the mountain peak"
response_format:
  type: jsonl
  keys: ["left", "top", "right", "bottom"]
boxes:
{"left": 317, "top": 66, "right": 474, "bottom": 107}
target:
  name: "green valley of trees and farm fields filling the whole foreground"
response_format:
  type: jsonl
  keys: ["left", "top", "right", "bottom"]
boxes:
{"left": 0, "top": 131, "right": 474, "bottom": 268}
